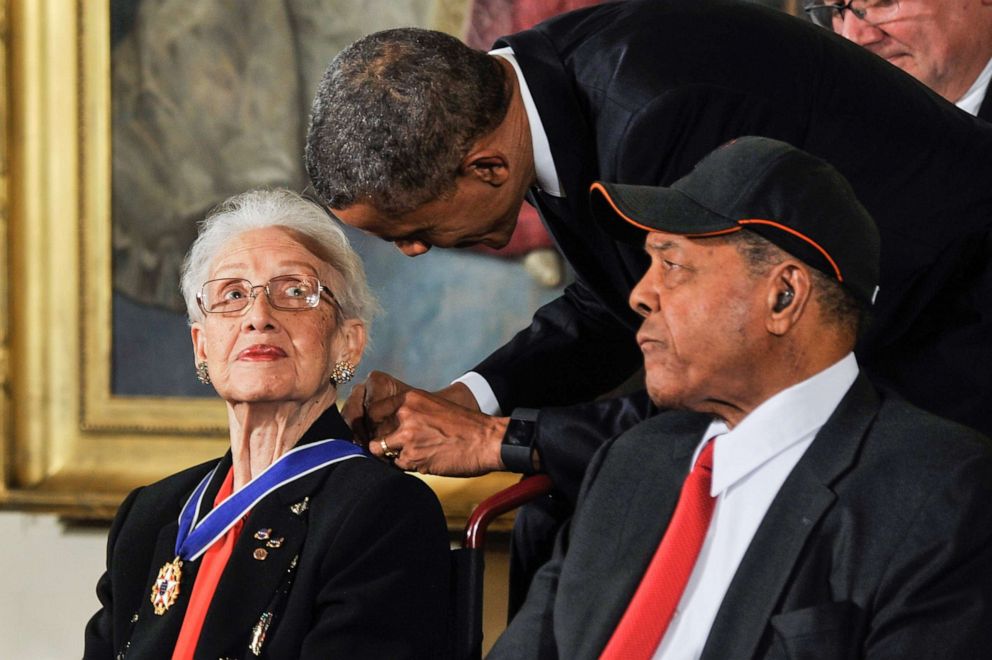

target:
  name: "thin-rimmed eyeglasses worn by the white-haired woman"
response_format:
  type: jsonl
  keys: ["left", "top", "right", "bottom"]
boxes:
{"left": 196, "top": 275, "right": 337, "bottom": 314}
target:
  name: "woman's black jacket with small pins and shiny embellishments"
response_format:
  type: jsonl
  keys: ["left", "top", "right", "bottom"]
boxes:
{"left": 85, "top": 407, "right": 450, "bottom": 659}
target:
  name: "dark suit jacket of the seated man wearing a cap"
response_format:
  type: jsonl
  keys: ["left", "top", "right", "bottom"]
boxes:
{"left": 489, "top": 376, "right": 992, "bottom": 660}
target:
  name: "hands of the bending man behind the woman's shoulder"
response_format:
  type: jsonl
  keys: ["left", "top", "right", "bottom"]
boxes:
{"left": 342, "top": 371, "right": 509, "bottom": 477}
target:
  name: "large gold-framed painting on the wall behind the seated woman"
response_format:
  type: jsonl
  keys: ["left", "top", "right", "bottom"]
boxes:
{"left": 0, "top": 0, "right": 558, "bottom": 526}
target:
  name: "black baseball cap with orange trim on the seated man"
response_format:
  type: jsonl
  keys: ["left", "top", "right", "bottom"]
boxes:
{"left": 589, "top": 136, "right": 879, "bottom": 304}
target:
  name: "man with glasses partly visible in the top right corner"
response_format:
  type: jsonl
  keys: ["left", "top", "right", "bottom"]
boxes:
{"left": 804, "top": 0, "right": 992, "bottom": 116}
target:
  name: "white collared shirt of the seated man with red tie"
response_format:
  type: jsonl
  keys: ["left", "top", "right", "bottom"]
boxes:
{"left": 654, "top": 353, "right": 858, "bottom": 660}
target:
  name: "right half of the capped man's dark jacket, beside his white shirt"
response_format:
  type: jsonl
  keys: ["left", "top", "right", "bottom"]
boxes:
{"left": 702, "top": 376, "right": 992, "bottom": 660}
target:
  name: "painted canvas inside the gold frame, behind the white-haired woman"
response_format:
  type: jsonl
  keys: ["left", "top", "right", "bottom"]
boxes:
{"left": 110, "top": 0, "right": 560, "bottom": 397}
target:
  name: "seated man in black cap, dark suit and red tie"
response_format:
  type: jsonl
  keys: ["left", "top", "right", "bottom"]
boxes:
{"left": 490, "top": 137, "right": 992, "bottom": 660}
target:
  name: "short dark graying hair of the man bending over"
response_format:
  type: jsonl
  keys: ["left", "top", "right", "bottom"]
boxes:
{"left": 305, "top": 28, "right": 511, "bottom": 215}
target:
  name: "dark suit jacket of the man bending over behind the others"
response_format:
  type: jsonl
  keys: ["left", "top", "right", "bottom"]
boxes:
{"left": 476, "top": 0, "right": 992, "bottom": 490}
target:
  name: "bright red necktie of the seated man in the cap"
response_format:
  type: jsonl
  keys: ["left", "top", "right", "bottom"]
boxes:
{"left": 600, "top": 440, "right": 716, "bottom": 660}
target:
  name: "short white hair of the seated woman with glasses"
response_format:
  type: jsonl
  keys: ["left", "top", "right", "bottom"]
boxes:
{"left": 181, "top": 188, "right": 379, "bottom": 332}
